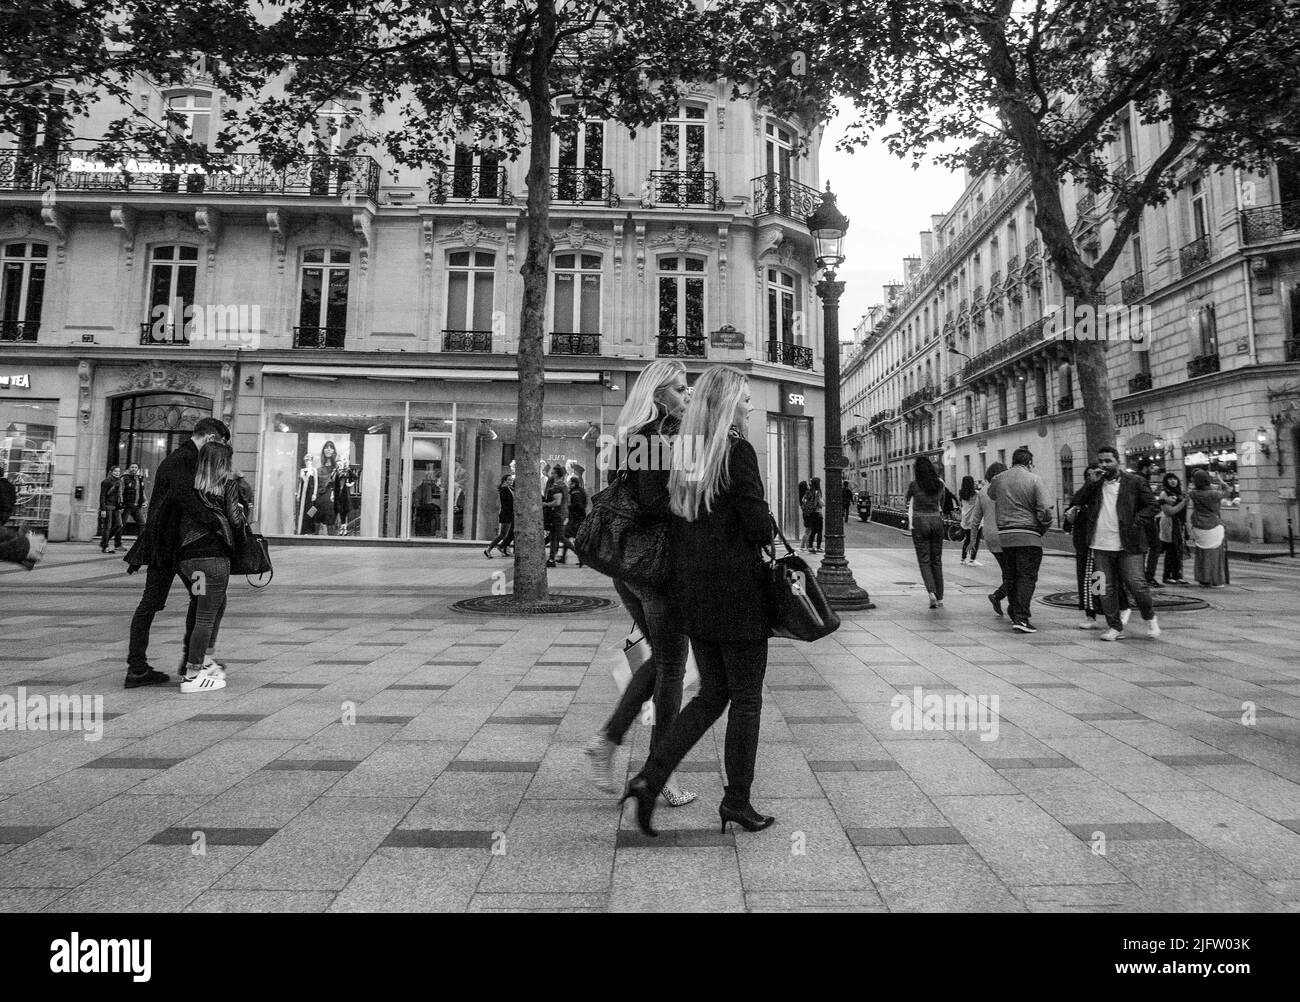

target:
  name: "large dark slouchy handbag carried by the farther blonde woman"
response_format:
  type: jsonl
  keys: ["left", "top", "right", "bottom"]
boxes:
{"left": 573, "top": 470, "right": 671, "bottom": 589}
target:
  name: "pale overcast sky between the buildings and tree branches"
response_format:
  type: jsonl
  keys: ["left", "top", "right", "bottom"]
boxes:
{"left": 820, "top": 100, "right": 962, "bottom": 340}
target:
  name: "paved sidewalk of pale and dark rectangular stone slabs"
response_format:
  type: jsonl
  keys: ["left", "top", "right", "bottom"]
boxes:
{"left": 0, "top": 532, "right": 1300, "bottom": 911}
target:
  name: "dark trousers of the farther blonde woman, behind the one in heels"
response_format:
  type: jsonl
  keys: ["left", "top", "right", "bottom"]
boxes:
{"left": 605, "top": 578, "right": 688, "bottom": 750}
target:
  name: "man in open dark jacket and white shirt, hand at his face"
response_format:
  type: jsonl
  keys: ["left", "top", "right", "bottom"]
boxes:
{"left": 1080, "top": 446, "right": 1160, "bottom": 641}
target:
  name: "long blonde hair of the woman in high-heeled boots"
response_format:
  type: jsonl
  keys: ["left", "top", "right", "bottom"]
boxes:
{"left": 668, "top": 365, "right": 749, "bottom": 522}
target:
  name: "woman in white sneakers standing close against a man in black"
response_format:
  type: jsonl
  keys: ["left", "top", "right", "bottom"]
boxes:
{"left": 167, "top": 442, "right": 246, "bottom": 694}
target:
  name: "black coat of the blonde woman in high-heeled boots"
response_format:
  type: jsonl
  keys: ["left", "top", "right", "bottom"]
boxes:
{"left": 670, "top": 437, "right": 772, "bottom": 645}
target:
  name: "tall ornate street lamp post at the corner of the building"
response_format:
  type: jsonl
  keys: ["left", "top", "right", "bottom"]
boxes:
{"left": 807, "top": 182, "right": 875, "bottom": 610}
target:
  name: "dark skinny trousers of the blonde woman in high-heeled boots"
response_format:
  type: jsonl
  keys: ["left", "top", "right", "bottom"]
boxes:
{"left": 641, "top": 639, "right": 767, "bottom": 810}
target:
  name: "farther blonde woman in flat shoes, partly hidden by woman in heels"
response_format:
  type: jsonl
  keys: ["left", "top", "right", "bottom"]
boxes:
{"left": 586, "top": 359, "right": 697, "bottom": 807}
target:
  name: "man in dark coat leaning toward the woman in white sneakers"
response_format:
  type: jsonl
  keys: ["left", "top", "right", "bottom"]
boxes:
{"left": 125, "top": 417, "right": 230, "bottom": 689}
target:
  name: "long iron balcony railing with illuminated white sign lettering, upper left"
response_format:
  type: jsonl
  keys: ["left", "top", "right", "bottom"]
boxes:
{"left": 0, "top": 149, "right": 380, "bottom": 200}
